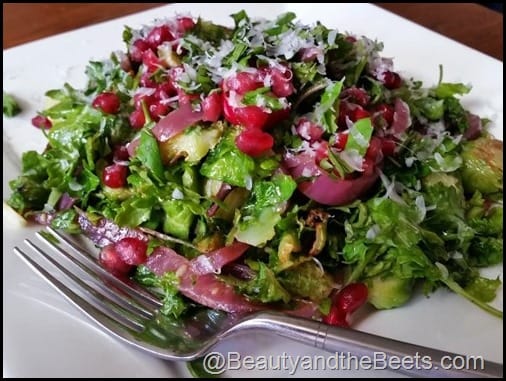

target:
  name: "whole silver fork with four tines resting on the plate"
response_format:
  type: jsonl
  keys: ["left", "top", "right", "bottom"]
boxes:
{"left": 14, "top": 228, "right": 503, "bottom": 377}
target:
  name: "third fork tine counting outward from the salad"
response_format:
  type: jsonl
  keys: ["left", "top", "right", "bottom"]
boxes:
{"left": 22, "top": 239, "right": 144, "bottom": 332}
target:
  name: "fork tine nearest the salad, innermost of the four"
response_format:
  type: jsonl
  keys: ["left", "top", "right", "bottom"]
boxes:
{"left": 45, "top": 226, "right": 162, "bottom": 308}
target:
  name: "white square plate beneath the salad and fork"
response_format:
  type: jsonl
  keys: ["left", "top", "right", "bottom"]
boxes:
{"left": 3, "top": 4, "right": 503, "bottom": 378}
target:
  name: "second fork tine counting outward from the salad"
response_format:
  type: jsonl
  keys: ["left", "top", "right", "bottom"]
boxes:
{"left": 35, "top": 229, "right": 156, "bottom": 318}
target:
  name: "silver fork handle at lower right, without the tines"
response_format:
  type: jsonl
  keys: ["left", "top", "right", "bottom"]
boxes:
{"left": 230, "top": 312, "right": 503, "bottom": 378}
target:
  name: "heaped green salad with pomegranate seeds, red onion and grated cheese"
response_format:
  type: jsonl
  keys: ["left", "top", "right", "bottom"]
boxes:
{"left": 8, "top": 11, "right": 503, "bottom": 326}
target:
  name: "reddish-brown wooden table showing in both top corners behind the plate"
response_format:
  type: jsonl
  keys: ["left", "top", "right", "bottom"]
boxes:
{"left": 3, "top": 3, "right": 503, "bottom": 61}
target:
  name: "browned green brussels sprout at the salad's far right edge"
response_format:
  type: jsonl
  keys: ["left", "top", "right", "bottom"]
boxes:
{"left": 461, "top": 137, "right": 503, "bottom": 194}
